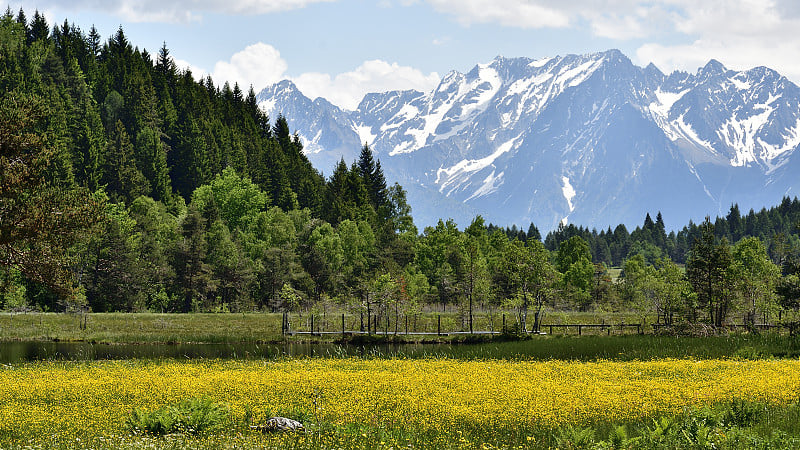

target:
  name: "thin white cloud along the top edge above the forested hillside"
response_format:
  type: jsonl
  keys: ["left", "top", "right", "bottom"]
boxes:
{"left": 16, "top": 0, "right": 335, "bottom": 23}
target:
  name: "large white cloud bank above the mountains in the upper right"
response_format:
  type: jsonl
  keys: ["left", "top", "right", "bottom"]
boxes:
{"left": 426, "top": 0, "right": 800, "bottom": 80}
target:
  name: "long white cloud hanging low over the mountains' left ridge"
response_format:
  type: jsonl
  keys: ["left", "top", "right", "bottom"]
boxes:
{"left": 292, "top": 60, "right": 441, "bottom": 110}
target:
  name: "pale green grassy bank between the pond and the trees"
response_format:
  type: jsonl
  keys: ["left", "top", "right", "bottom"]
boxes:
{"left": 0, "top": 311, "right": 664, "bottom": 344}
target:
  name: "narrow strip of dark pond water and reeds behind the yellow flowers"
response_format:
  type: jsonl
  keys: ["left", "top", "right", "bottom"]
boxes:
{"left": 0, "top": 334, "right": 772, "bottom": 364}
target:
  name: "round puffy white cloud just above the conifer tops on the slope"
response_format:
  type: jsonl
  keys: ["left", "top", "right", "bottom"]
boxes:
{"left": 212, "top": 42, "right": 289, "bottom": 90}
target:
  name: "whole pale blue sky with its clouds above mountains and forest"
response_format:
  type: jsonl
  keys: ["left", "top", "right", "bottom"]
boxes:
{"left": 10, "top": 0, "right": 800, "bottom": 108}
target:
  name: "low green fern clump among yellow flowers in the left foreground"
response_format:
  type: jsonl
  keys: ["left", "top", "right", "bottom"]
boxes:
{"left": 128, "top": 398, "right": 230, "bottom": 436}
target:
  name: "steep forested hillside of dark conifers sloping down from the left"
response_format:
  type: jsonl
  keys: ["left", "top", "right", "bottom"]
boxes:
{"left": 0, "top": 10, "right": 415, "bottom": 311}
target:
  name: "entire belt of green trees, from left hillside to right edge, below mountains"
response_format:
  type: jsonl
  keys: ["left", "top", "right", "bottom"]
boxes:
{"left": 0, "top": 10, "right": 800, "bottom": 327}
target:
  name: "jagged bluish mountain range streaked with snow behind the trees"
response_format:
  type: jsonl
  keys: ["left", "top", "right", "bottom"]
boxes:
{"left": 258, "top": 50, "right": 800, "bottom": 231}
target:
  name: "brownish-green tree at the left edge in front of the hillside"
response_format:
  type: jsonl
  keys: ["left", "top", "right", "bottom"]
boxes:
{"left": 0, "top": 92, "right": 103, "bottom": 299}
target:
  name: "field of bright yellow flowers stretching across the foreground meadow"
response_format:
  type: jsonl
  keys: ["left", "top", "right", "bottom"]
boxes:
{"left": 0, "top": 359, "right": 800, "bottom": 442}
